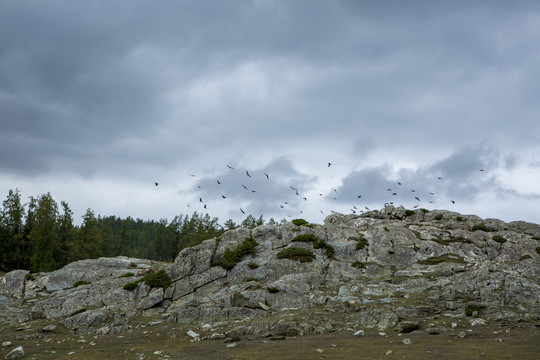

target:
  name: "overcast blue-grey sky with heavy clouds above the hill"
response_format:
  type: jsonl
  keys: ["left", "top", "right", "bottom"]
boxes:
{"left": 0, "top": 0, "right": 540, "bottom": 223}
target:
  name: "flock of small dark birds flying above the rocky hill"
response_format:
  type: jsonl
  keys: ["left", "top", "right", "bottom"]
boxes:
{"left": 154, "top": 162, "right": 484, "bottom": 217}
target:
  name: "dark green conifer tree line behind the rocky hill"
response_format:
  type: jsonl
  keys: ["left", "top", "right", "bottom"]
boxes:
{"left": 0, "top": 189, "right": 276, "bottom": 272}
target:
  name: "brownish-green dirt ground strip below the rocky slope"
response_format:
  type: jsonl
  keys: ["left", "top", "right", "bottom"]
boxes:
{"left": 0, "top": 323, "right": 540, "bottom": 360}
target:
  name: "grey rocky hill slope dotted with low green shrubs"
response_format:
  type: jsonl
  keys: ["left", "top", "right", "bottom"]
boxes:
{"left": 0, "top": 206, "right": 540, "bottom": 338}
